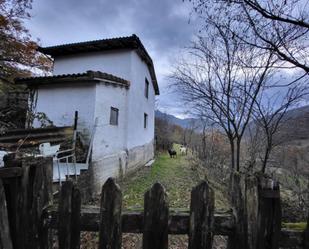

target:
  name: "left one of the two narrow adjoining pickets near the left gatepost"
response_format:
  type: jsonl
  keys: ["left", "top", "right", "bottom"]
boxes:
{"left": 58, "top": 181, "right": 73, "bottom": 249}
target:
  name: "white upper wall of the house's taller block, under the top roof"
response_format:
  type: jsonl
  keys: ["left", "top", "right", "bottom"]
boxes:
{"left": 54, "top": 50, "right": 155, "bottom": 151}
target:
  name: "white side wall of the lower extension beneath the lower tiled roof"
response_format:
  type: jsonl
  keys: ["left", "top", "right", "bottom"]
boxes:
{"left": 34, "top": 82, "right": 96, "bottom": 138}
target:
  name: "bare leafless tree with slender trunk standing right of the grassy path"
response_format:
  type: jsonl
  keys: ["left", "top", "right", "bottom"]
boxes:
{"left": 173, "top": 18, "right": 276, "bottom": 171}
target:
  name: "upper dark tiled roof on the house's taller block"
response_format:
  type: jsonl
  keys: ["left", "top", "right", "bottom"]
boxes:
{"left": 38, "top": 35, "right": 160, "bottom": 95}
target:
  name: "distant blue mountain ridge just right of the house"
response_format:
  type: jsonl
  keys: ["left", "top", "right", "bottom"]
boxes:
{"left": 155, "top": 110, "right": 203, "bottom": 131}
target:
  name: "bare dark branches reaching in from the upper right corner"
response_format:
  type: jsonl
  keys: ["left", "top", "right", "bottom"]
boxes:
{"left": 192, "top": 0, "right": 309, "bottom": 75}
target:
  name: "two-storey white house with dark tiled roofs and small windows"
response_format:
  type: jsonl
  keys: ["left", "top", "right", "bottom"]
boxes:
{"left": 16, "top": 35, "right": 159, "bottom": 190}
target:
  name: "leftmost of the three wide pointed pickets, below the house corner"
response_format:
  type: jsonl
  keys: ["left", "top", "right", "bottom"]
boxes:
{"left": 99, "top": 178, "right": 122, "bottom": 249}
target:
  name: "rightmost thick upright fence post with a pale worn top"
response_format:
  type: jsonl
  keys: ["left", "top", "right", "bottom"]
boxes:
{"left": 257, "top": 177, "right": 281, "bottom": 249}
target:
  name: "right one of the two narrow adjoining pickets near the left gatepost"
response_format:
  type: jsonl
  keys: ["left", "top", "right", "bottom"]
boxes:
{"left": 71, "top": 186, "right": 81, "bottom": 249}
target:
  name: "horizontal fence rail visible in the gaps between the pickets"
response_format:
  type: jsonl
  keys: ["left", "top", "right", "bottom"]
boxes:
{"left": 46, "top": 206, "right": 235, "bottom": 235}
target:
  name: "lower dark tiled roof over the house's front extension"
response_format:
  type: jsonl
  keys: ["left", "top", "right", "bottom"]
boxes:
{"left": 15, "top": 71, "right": 130, "bottom": 87}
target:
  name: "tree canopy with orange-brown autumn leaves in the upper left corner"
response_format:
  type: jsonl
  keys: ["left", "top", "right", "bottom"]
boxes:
{"left": 0, "top": 0, "right": 51, "bottom": 81}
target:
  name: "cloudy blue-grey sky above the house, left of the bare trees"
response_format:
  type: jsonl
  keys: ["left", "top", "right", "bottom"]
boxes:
{"left": 26, "top": 0, "right": 199, "bottom": 117}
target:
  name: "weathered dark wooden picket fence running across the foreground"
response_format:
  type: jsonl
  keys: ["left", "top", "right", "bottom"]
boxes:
{"left": 0, "top": 158, "right": 309, "bottom": 249}
